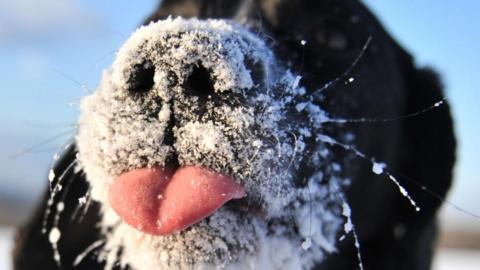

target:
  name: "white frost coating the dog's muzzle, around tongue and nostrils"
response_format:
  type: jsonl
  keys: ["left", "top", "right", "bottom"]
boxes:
{"left": 76, "top": 18, "right": 352, "bottom": 269}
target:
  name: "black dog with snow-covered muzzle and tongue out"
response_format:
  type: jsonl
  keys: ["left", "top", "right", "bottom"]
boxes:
{"left": 14, "top": 0, "right": 455, "bottom": 269}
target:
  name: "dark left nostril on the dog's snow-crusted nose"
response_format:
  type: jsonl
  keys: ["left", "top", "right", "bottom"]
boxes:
{"left": 127, "top": 60, "right": 155, "bottom": 93}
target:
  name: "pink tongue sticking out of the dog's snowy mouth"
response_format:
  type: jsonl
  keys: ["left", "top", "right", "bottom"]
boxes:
{"left": 109, "top": 166, "right": 245, "bottom": 235}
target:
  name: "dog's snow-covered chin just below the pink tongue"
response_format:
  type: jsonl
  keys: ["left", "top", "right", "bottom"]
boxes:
{"left": 101, "top": 208, "right": 269, "bottom": 269}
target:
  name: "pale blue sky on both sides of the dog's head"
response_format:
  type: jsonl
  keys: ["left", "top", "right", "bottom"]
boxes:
{"left": 0, "top": 0, "right": 480, "bottom": 230}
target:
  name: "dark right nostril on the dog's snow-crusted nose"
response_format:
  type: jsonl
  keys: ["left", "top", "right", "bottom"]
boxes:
{"left": 185, "top": 65, "right": 215, "bottom": 101}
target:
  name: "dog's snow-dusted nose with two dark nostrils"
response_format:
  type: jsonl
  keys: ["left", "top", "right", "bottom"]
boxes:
{"left": 117, "top": 19, "right": 272, "bottom": 101}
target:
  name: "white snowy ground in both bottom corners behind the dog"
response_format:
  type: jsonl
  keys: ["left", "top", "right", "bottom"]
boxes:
{"left": 0, "top": 227, "right": 480, "bottom": 270}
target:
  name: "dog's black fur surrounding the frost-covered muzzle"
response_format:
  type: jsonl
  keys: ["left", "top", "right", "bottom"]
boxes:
{"left": 14, "top": 0, "right": 455, "bottom": 270}
